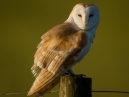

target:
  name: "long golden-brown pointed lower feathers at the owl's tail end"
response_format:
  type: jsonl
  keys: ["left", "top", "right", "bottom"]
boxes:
{"left": 27, "top": 69, "right": 64, "bottom": 97}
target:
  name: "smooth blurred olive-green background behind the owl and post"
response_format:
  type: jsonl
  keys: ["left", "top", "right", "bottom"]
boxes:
{"left": 0, "top": 0, "right": 129, "bottom": 97}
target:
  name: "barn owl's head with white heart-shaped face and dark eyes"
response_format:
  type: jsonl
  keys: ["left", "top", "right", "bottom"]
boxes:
{"left": 66, "top": 3, "right": 100, "bottom": 30}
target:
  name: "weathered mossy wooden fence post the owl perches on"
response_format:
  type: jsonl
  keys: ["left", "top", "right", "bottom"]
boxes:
{"left": 59, "top": 75, "right": 92, "bottom": 97}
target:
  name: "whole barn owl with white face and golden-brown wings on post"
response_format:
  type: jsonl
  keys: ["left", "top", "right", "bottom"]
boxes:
{"left": 28, "top": 3, "right": 100, "bottom": 97}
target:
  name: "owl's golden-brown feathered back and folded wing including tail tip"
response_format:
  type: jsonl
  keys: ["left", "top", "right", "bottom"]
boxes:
{"left": 28, "top": 23, "right": 87, "bottom": 95}
